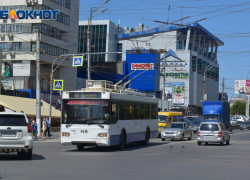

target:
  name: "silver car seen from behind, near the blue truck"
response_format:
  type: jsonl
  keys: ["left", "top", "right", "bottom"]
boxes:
{"left": 197, "top": 121, "right": 230, "bottom": 145}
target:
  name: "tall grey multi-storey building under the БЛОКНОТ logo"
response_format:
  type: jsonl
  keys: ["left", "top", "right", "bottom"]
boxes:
{"left": 0, "top": 0, "right": 79, "bottom": 98}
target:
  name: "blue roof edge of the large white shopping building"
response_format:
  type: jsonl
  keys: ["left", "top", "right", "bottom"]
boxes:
{"left": 116, "top": 22, "right": 224, "bottom": 46}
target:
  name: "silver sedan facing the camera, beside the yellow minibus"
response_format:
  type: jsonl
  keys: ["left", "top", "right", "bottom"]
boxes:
{"left": 161, "top": 122, "right": 192, "bottom": 141}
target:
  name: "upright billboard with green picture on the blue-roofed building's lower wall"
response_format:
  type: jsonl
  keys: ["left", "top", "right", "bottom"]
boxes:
{"left": 173, "top": 83, "right": 184, "bottom": 105}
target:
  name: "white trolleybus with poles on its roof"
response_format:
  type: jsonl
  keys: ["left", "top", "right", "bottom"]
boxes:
{"left": 61, "top": 80, "right": 158, "bottom": 150}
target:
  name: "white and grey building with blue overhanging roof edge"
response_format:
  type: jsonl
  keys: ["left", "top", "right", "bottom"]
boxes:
{"left": 117, "top": 23, "right": 224, "bottom": 113}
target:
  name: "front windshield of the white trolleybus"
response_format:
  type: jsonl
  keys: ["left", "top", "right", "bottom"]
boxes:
{"left": 62, "top": 99, "right": 110, "bottom": 124}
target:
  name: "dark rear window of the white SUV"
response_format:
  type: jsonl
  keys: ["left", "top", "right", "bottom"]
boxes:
{"left": 0, "top": 115, "right": 27, "bottom": 126}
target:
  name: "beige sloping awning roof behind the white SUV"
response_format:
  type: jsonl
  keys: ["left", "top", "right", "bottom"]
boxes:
{"left": 0, "top": 95, "right": 61, "bottom": 118}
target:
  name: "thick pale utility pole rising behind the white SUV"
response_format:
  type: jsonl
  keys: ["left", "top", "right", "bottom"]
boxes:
{"left": 36, "top": 29, "right": 41, "bottom": 136}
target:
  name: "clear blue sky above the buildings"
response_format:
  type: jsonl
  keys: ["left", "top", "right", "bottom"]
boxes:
{"left": 80, "top": 0, "right": 250, "bottom": 97}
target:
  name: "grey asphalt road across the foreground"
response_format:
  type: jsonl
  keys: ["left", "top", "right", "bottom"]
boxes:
{"left": 0, "top": 130, "right": 250, "bottom": 180}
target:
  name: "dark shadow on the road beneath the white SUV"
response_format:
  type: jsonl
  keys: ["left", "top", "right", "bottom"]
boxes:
{"left": 0, "top": 153, "right": 45, "bottom": 161}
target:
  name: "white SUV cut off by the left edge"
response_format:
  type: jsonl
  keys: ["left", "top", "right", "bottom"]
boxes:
{"left": 0, "top": 112, "right": 33, "bottom": 159}
